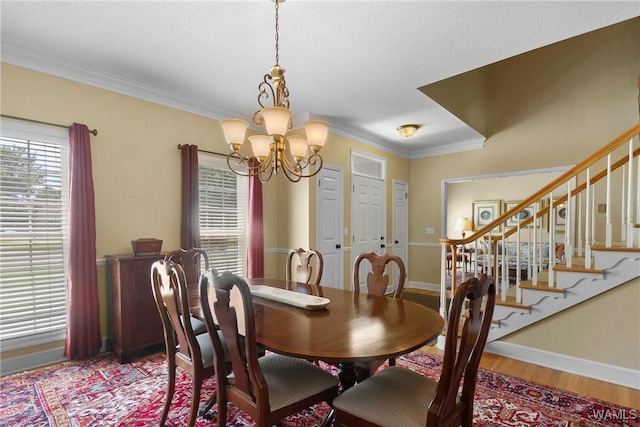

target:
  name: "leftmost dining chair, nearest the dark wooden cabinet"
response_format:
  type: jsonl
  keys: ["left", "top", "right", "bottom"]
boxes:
{"left": 151, "top": 260, "right": 215, "bottom": 427}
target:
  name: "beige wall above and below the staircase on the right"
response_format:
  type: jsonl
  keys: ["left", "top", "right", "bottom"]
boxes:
{"left": 409, "top": 18, "right": 640, "bottom": 370}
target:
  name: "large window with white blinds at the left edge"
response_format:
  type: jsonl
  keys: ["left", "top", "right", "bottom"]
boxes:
{"left": 0, "top": 119, "right": 69, "bottom": 350}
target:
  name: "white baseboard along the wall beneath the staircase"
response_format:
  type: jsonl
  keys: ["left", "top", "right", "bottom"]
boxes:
{"left": 485, "top": 341, "right": 640, "bottom": 390}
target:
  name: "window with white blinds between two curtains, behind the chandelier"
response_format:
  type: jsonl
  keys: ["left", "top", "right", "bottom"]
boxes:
{"left": 198, "top": 153, "right": 249, "bottom": 276}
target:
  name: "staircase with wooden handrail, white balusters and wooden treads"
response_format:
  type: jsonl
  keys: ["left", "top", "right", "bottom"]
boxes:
{"left": 440, "top": 123, "right": 640, "bottom": 342}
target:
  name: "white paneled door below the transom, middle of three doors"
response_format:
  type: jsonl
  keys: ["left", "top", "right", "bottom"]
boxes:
{"left": 351, "top": 175, "right": 386, "bottom": 289}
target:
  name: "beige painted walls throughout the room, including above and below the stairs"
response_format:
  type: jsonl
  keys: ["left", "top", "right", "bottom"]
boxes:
{"left": 0, "top": 19, "right": 640, "bottom": 369}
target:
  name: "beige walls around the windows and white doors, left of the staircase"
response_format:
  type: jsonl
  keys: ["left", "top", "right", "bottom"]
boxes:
{"left": 0, "top": 63, "right": 409, "bottom": 358}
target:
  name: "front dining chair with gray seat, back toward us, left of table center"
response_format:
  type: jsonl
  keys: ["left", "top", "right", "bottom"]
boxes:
{"left": 201, "top": 272, "right": 338, "bottom": 427}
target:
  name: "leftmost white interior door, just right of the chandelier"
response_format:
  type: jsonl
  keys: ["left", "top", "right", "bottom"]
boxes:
{"left": 316, "top": 165, "right": 344, "bottom": 289}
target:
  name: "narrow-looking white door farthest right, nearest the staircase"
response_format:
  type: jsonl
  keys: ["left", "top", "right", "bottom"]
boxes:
{"left": 391, "top": 180, "right": 409, "bottom": 291}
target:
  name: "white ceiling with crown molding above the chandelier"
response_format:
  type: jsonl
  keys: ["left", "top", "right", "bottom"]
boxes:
{"left": 0, "top": 0, "right": 640, "bottom": 158}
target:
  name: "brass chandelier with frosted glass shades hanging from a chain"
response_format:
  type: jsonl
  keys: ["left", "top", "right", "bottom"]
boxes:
{"left": 220, "top": 0, "right": 330, "bottom": 182}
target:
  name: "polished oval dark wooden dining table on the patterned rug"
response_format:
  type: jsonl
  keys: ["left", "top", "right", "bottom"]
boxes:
{"left": 189, "top": 279, "right": 444, "bottom": 389}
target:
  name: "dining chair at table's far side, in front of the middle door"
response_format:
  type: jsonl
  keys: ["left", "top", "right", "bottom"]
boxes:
{"left": 353, "top": 252, "right": 406, "bottom": 381}
